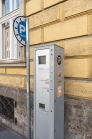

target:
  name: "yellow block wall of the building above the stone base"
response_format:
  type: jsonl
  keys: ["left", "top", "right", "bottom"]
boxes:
{"left": 0, "top": 0, "right": 92, "bottom": 99}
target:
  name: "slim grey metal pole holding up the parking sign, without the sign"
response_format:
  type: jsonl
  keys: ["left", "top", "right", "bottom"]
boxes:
{"left": 26, "top": 18, "right": 31, "bottom": 139}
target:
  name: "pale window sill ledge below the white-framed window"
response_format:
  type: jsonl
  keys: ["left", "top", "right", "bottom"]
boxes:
{"left": 0, "top": 59, "right": 26, "bottom": 67}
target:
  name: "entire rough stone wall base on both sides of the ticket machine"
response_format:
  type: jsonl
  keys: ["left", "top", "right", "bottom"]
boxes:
{"left": 0, "top": 85, "right": 92, "bottom": 139}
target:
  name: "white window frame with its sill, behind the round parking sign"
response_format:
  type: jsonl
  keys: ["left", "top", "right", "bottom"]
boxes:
{"left": 0, "top": 0, "right": 26, "bottom": 67}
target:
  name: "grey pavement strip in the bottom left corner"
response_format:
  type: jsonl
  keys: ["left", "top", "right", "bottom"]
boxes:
{"left": 0, "top": 123, "right": 26, "bottom": 139}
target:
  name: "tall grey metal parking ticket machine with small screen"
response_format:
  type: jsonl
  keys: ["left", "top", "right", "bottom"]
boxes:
{"left": 34, "top": 44, "right": 64, "bottom": 139}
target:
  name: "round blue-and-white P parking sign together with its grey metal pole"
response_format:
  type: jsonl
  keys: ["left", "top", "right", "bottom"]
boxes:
{"left": 13, "top": 16, "right": 31, "bottom": 139}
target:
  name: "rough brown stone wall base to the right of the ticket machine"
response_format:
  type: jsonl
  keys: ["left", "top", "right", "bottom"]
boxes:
{"left": 65, "top": 96, "right": 92, "bottom": 139}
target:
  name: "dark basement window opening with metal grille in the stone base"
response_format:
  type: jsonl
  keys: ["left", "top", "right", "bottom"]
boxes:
{"left": 0, "top": 95, "right": 16, "bottom": 122}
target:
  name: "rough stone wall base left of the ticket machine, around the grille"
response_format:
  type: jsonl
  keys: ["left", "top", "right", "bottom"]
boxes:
{"left": 0, "top": 85, "right": 33, "bottom": 137}
